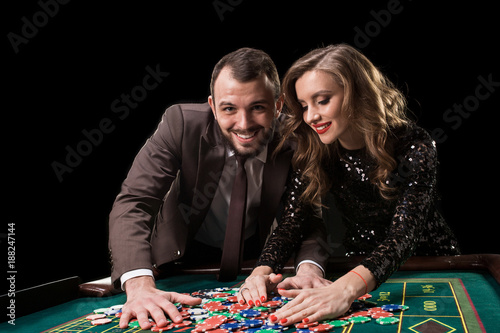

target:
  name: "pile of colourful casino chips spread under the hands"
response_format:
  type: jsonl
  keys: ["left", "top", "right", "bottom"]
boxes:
{"left": 87, "top": 288, "right": 408, "bottom": 333}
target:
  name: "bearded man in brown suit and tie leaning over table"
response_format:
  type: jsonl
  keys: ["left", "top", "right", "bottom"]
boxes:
{"left": 109, "top": 48, "right": 324, "bottom": 329}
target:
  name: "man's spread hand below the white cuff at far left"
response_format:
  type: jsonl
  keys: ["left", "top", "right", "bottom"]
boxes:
{"left": 120, "top": 276, "right": 201, "bottom": 330}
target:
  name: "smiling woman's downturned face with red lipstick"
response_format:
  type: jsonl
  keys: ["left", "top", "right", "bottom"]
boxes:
{"left": 295, "top": 70, "right": 364, "bottom": 149}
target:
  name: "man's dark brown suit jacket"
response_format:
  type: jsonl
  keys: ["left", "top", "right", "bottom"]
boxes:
{"left": 109, "top": 103, "right": 326, "bottom": 283}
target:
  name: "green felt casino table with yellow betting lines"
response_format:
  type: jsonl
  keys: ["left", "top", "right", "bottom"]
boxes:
{"left": 0, "top": 255, "right": 500, "bottom": 333}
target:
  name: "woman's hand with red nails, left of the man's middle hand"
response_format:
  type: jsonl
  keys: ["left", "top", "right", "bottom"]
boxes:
{"left": 238, "top": 266, "right": 283, "bottom": 306}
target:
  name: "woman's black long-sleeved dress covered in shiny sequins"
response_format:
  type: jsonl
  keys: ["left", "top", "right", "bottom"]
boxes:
{"left": 257, "top": 125, "right": 460, "bottom": 287}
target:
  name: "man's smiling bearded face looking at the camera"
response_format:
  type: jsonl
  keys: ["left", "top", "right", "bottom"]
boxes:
{"left": 208, "top": 68, "right": 281, "bottom": 157}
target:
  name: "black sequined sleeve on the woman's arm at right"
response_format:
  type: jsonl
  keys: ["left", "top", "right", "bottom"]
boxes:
{"left": 361, "top": 138, "right": 437, "bottom": 288}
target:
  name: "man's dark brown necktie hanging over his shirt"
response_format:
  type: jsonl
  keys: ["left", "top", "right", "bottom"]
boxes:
{"left": 218, "top": 156, "right": 247, "bottom": 281}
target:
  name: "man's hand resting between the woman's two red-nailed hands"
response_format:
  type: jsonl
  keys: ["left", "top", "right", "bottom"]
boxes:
{"left": 278, "top": 263, "right": 332, "bottom": 289}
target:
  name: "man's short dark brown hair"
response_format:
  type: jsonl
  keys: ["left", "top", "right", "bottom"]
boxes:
{"left": 210, "top": 47, "right": 280, "bottom": 100}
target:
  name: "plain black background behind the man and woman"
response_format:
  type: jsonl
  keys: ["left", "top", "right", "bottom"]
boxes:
{"left": 0, "top": 0, "right": 500, "bottom": 294}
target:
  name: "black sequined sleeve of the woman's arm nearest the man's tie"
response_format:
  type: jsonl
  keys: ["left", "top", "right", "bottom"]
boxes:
{"left": 256, "top": 171, "right": 319, "bottom": 273}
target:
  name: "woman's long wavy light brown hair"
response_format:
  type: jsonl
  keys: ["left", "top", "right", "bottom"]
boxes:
{"left": 278, "top": 44, "right": 409, "bottom": 206}
